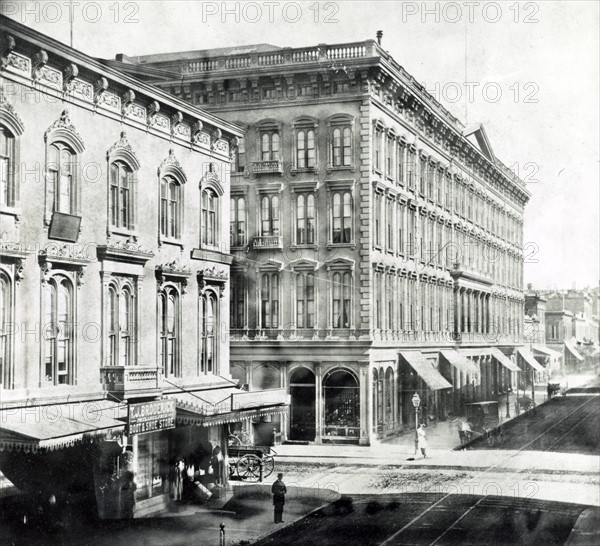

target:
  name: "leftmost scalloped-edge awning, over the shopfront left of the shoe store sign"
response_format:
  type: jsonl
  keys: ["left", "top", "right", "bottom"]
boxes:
{"left": 0, "top": 400, "right": 126, "bottom": 453}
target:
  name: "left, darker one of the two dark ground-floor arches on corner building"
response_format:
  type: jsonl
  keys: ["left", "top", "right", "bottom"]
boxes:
{"left": 290, "top": 368, "right": 315, "bottom": 442}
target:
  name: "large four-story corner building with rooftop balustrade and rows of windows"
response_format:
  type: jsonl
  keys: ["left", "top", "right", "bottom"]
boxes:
{"left": 115, "top": 35, "right": 529, "bottom": 444}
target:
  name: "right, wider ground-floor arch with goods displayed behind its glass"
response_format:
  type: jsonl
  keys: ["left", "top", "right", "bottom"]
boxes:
{"left": 323, "top": 370, "right": 360, "bottom": 441}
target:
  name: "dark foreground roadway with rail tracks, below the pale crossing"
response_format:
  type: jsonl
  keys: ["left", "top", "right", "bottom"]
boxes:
{"left": 255, "top": 493, "right": 587, "bottom": 546}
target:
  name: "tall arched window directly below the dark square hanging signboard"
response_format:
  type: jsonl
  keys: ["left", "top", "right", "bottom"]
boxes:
{"left": 43, "top": 275, "right": 74, "bottom": 385}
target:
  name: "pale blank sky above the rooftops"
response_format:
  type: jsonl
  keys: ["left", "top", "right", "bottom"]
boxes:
{"left": 0, "top": 0, "right": 600, "bottom": 289}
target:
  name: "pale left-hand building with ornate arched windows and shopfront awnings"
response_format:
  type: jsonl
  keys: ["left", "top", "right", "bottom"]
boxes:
{"left": 0, "top": 17, "right": 287, "bottom": 517}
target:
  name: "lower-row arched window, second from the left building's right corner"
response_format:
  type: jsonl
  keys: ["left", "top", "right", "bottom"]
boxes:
{"left": 158, "top": 286, "right": 181, "bottom": 377}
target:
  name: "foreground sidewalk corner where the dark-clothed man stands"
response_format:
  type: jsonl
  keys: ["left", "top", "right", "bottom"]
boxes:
{"left": 0, "top": 480, "right": 340, "bottom": 546}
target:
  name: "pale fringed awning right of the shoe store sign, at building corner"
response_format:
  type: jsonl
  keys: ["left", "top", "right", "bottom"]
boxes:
{"left": 166, "top": 387, "right": 289, "bottom": 426}
